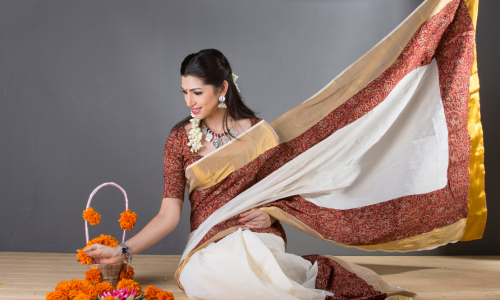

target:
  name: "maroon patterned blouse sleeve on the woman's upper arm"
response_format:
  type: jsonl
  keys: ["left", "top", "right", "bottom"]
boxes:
{"left": 163, "top": 128, "right": 186, "bottom": 201}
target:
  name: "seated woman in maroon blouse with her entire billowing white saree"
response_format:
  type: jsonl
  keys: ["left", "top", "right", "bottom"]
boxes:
{"left": 86, "top": 0, "right": 484, "bottom": 299}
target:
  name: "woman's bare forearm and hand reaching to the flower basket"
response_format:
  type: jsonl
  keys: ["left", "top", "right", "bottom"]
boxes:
{"left": 85, "top": 198, "right": 182, "bottom": 264}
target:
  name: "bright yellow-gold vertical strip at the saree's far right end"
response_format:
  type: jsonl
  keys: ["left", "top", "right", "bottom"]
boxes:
{"left": 461, "top": 0, "right": 487, "bottom": 241}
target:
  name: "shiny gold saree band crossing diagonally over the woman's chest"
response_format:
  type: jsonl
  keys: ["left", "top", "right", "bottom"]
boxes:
{"left": 185, "top": 121, "right": 278, "bottom": 195}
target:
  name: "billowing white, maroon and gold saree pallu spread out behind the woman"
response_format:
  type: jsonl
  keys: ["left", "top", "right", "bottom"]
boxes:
{"left": 176, "top": 0, "right": 486, "bottom": 292}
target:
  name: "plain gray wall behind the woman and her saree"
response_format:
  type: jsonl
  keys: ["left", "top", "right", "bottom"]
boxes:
{"left": 0, "top": 0, "right": 500, "bottom": 255}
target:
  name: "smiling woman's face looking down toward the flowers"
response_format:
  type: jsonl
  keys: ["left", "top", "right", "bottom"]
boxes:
{"left": 181, "top": 75, "right": 225, "bottom": 120}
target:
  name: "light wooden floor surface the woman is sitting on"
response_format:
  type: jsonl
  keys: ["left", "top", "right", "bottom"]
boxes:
{"left": 0, "top": 252, "right": 500, "bottom": 300}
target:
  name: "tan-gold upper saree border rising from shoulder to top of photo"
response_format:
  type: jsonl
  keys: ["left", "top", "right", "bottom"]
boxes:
{"left": 270, "top": 0, "right": 451, "bottom": 143}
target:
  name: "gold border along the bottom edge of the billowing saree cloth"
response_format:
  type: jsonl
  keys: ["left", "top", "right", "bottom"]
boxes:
{"left": 259, "top": 206, "right": 467, "bottom": 252}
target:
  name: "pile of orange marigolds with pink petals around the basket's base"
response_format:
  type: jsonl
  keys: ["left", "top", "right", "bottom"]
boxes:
{"left": 46, "top": 264, "right": 174, "bottom": 300}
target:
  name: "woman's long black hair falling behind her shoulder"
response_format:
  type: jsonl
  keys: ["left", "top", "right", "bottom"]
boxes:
{"left": 172, "top": 49, "right": 256, "bottom": 131}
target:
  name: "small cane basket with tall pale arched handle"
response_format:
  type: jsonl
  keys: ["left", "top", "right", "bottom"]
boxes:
{"left": 85, "top": 182, "right": 128, "bottom": 287}
